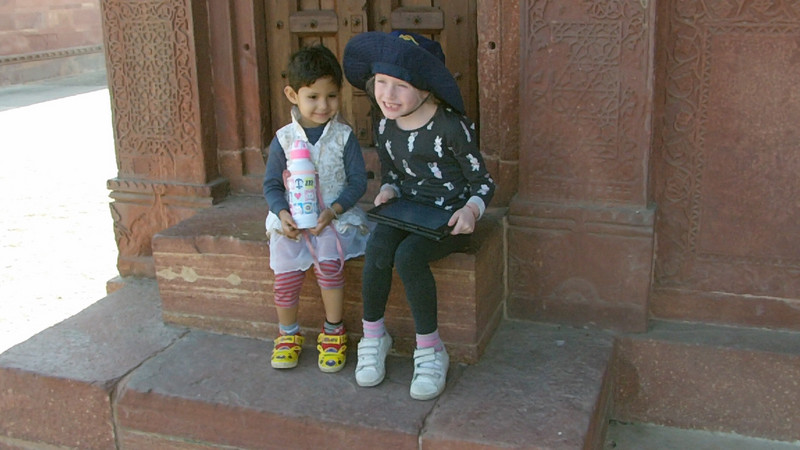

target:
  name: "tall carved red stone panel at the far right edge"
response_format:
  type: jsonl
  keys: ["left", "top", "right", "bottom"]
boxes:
{"left": 654, "top": 0, "right": 800, "bottom": 326}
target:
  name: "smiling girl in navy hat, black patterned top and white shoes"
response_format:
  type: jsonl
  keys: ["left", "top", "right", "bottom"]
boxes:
{"left": 343, "top": 31, "right": 495, "bottom": 400}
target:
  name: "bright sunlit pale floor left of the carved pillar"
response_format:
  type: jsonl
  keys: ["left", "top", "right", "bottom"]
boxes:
{"left": 0, "top": 73, "right": 117, "bottom": 353}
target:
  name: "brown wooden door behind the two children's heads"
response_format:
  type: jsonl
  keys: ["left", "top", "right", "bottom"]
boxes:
{"left": 265, "top": 0, "right": 478, "bottom": 147}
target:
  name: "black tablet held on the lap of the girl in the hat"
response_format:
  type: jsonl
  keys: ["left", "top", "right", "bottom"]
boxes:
{"left": 367, "top": 197, "right": 453, "bottom": 241}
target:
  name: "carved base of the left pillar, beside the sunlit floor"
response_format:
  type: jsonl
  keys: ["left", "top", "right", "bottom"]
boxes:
{"left": 108, "top": 178, "right": 230, "bottom": 277}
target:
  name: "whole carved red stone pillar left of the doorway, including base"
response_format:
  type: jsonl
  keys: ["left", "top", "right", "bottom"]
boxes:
{"left": 102, "top": 0, "right": 228, "bottom": 276}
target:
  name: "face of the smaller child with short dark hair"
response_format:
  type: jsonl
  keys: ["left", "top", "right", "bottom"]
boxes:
{"left": 284, "top": 77, "right": 339, "bottom": 128}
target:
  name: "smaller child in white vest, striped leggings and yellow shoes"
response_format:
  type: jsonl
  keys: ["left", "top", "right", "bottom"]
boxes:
{"left": 264, "top": 46, "right": 369, "bottom": 372}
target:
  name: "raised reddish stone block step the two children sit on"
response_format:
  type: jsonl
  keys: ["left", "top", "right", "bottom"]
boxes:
{"left": 153, "top": 196, "right": 505, "bottom": 363}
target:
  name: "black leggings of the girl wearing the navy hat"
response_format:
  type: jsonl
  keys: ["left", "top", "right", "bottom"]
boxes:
{"left": 361, "top": 225, "right": 470, "bottom": 334}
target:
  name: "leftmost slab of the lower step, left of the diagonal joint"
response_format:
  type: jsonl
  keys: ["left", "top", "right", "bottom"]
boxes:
{"left": 0, "top": 281, "right": 184, "bottom": 448}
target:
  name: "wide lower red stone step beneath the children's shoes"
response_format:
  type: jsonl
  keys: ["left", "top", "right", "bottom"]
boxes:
{"left": 0, "top": 280, "right": 614, "bottom": 449}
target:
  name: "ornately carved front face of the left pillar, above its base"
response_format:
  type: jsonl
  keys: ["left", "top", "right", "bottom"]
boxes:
{"left": 102, "top": 0, "right": 216, "bottom": 183}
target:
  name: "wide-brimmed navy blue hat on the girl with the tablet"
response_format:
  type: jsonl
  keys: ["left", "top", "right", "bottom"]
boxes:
{"left": 342, "top": 30, "right": 465, "bottom": 114}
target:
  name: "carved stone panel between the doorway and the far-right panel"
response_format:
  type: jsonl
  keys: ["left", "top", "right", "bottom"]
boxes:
{"left": 520, "top": 0, "right": 652, "bottom": 205}
